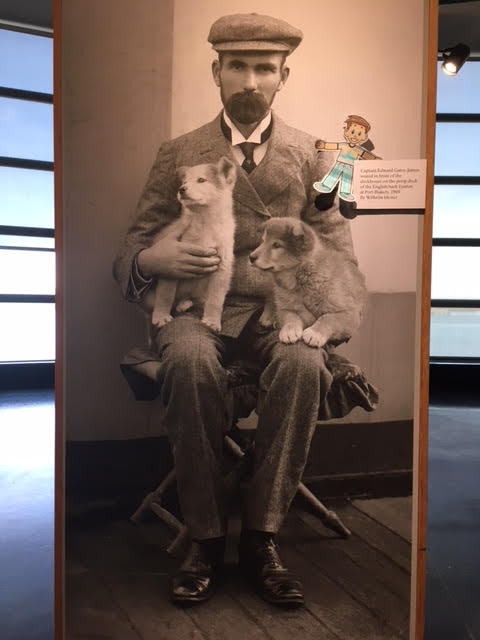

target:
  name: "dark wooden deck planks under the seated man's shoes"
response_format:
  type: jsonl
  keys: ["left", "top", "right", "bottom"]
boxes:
{"left": 67, "top": 505, "right": 409, "bottom": 640}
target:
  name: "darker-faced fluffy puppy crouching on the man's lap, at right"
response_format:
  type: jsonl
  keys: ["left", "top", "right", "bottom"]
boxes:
{"left": 250, "top": 217, "right": 366, "bottom": 347}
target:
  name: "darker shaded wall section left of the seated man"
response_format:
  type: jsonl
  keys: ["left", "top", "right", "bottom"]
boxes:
{"left": 62, "top": 0, "right": 173, "bottom": 440}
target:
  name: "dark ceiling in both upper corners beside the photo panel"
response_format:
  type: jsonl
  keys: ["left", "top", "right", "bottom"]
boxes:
{"left": 0, "top": 0, "right": 480, "bottom": 54}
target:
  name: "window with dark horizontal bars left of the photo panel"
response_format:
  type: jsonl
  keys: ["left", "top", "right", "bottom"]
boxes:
{"left": 0, "top": 23, "right": 55, "bottom": 363}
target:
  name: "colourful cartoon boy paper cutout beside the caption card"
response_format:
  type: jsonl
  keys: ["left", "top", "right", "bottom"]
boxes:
{"left": 313, "top": 115, "right": 379, "bottom": 202}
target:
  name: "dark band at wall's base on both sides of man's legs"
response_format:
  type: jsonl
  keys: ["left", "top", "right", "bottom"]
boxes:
{"left": 66, "top": 420, "right": 413, "bottom": 504}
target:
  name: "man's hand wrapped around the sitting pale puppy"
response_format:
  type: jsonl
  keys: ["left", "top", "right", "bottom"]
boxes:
{"left": 137, "top": 225, "right": 220, "bottom": 280}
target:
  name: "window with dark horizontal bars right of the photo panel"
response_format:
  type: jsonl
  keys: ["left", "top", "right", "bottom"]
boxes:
{"left": 430, "top": 60, "right": 480, "bottom": 362}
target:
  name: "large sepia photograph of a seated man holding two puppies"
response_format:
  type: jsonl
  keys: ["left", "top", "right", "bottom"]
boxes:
{"left": 62, "top": 0, "right": 428, "bottom": 640}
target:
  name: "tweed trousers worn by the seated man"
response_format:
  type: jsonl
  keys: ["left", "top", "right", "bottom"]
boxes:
{"left": 156, "top": 314, "right": 332, "bottom": 540}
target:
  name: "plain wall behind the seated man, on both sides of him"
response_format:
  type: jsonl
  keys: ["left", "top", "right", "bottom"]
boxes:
{"left": 62, "top": 0, "right": 424, "bottom": 440}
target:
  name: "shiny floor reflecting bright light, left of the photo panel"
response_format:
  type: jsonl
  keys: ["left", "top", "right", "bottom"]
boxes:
{"left": 0, "top": 391, "right": 54, "bottom": 640}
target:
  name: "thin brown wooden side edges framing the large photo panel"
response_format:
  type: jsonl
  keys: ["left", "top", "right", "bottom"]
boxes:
{"left": 53, "top": 0, "right": 438, "bottom": 640}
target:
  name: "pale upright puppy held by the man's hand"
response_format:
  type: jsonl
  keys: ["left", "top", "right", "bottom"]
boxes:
{"left": 145, "top": 157, "right": 236, "bottom": 331}
